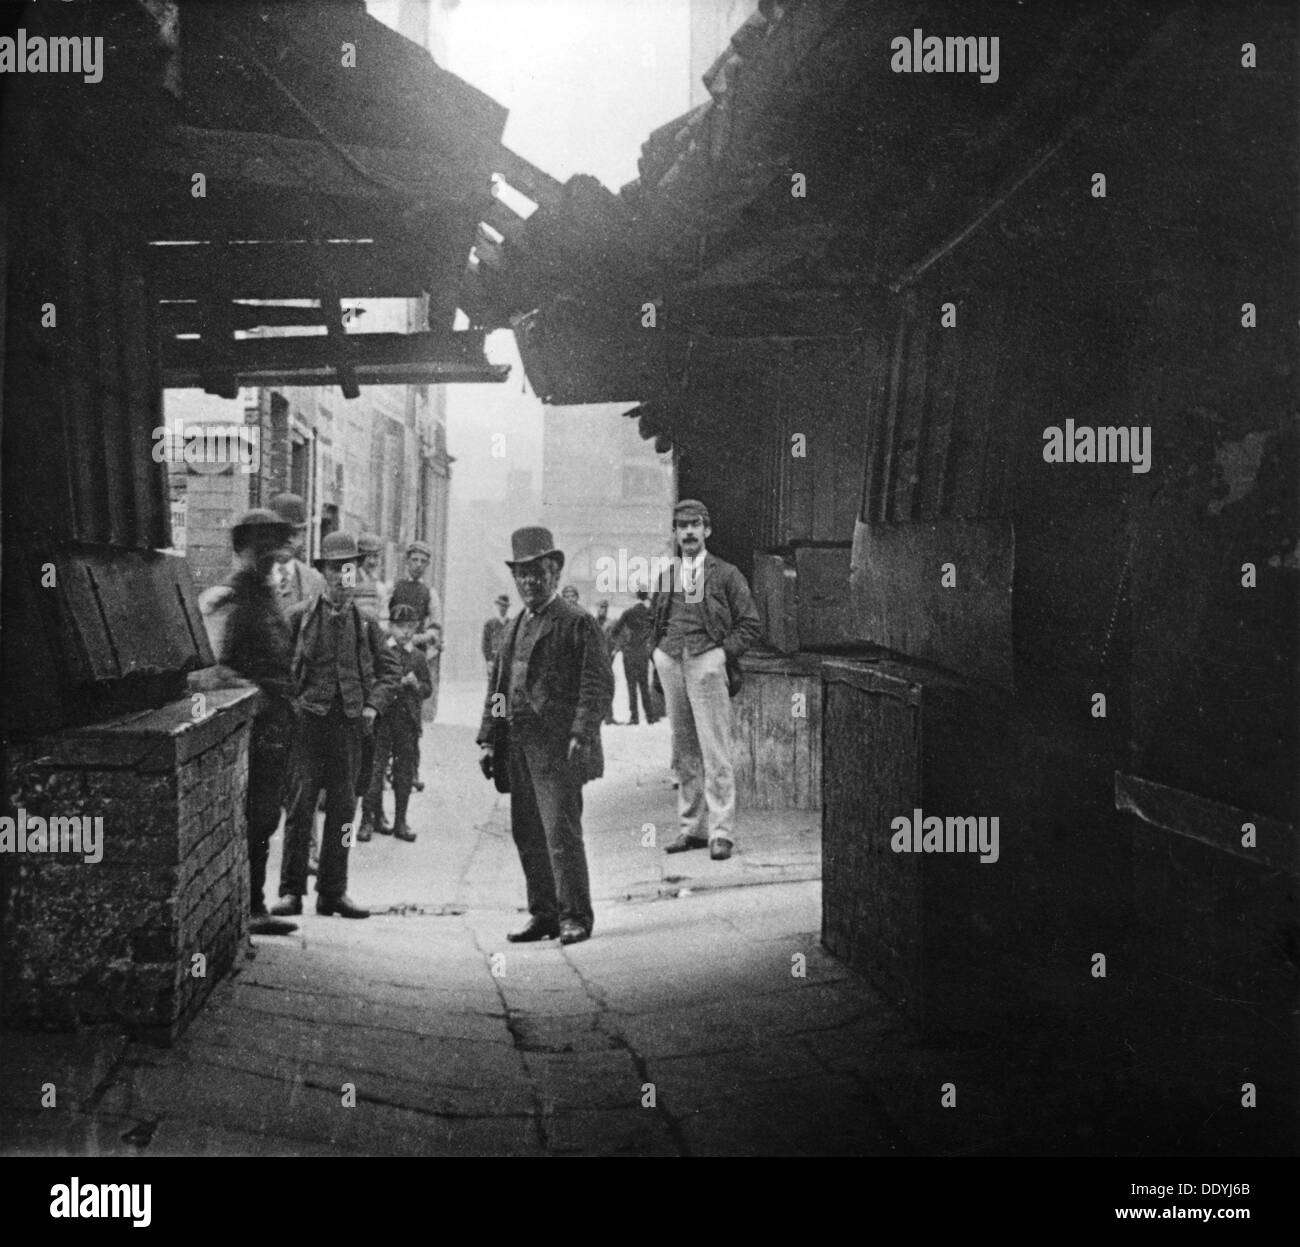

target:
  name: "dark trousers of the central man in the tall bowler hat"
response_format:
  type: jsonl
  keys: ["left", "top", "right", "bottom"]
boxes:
{"left": 510, "top": 724, "right": 594, "bottom": 931}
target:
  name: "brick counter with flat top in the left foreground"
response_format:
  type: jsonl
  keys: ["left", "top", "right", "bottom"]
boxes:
{"left": 0, "top": 689, "right": 256, "bottom": 1043}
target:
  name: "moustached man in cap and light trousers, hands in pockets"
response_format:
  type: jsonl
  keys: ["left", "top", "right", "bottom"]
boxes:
{"left": 650, "top": 498, "right": 762, "bottom": 861}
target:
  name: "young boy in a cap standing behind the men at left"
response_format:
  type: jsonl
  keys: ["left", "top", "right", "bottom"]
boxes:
{"left": 356, "top": 603, "right": 433, "bottom": 840}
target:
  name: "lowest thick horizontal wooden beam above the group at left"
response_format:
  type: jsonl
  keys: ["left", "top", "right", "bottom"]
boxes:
{"left": 163, "top": 333, "right": 510, "bottom": 389}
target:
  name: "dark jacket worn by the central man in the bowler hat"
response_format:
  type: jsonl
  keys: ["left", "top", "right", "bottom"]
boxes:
{"left": 478, "top": 598, "right": 614, "bottom": 783}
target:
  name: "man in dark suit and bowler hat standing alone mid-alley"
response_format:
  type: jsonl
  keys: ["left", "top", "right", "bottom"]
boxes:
{"left": 478, "top": 528, "right": 614, "bottom": 944}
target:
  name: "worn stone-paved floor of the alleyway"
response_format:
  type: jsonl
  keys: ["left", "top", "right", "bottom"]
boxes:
{"left": 0, "top": 687, "right": 1180, "bottom": 1156}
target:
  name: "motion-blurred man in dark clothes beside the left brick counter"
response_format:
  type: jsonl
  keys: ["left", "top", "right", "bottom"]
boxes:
{"left": 190, "top": 510, "right": 298, "bottom": 935}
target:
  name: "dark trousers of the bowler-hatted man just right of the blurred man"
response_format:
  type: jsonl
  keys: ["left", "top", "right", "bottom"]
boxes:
{"left": 280, "top": 707, "right": 364, "bottom": 900}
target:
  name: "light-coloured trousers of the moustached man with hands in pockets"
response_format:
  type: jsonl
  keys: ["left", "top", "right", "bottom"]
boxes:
{"left": 654, "top": 646, "right": 736, "bottom": 840}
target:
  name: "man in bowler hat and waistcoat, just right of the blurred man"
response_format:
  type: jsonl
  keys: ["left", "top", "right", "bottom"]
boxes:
{"left": 272, "top": 533, "right": 402, "bottom": 918}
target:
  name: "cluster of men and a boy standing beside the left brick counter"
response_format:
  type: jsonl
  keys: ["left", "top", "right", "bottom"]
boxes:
{"left": 192, "top": 494, "right": 442, "bottom": 934}
